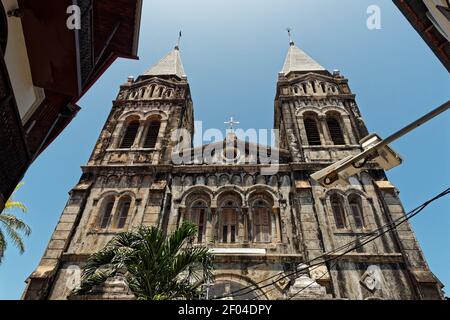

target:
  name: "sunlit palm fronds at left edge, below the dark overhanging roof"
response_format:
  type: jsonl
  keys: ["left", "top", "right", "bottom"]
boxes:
{"left": 0, "top": 183, "right": 31, "bottom": 264}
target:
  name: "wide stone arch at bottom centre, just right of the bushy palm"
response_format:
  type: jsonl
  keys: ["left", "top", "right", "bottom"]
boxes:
{"left": 207, "top": 273, "right": 269, "bottom": 300}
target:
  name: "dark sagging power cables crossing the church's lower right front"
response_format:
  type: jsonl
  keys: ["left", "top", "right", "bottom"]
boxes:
{"left": 216, "top": 188, "right": 450, "bottom": 299}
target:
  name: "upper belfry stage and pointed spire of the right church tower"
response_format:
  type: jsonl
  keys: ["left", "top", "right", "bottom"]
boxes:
{"left": 275, "top": 40, "right": 367, "bottom": 162}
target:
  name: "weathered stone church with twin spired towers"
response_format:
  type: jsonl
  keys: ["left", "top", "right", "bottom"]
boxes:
{"left": 23, "top": 42, "right": 443, "bottom": 300}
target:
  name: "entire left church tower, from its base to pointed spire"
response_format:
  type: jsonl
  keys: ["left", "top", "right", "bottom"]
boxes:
{"left": 23, "top": 45, "right": 194, "bottom": 300}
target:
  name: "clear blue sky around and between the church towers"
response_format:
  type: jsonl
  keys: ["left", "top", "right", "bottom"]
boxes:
{"left": 0, "top": 0, "right": 450, "bottom": 299}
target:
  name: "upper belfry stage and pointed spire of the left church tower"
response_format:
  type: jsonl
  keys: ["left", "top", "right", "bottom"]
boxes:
{"left": 89, "top": 45, "right": 194, "bottom": 165}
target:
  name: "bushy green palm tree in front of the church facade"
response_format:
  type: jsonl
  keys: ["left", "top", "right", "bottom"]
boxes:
{"left": 75, "top": 222, "right": 212, "bottom": 300}
